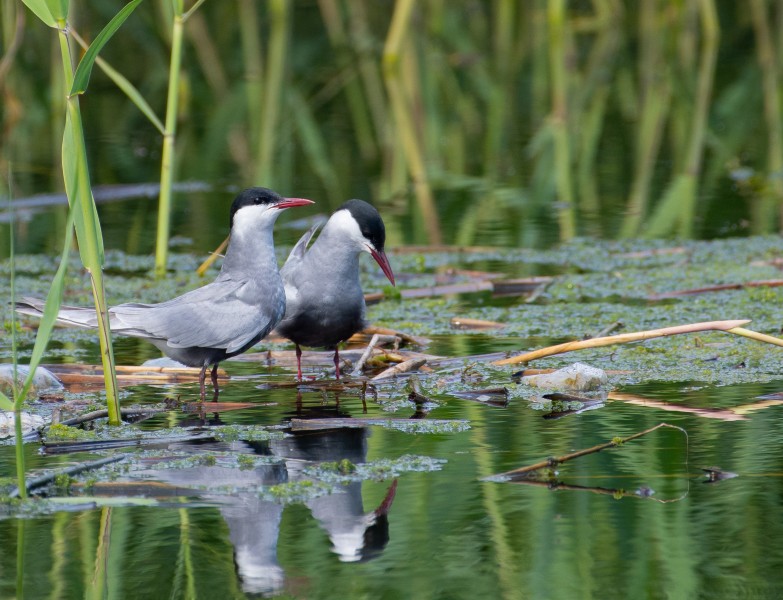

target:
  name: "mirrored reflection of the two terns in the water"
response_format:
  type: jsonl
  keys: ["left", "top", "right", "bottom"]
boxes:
{"left": 137, "top": 418, "right": 397, "bottom": 594}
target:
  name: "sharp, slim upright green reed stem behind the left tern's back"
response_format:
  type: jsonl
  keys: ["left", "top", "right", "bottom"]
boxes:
{"left": 155, "top": 0, "right": 185, "bottom": 277}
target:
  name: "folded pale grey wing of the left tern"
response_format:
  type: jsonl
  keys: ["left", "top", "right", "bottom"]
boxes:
{"left": 111, "top": 280, "right": 276, "bottom": 352}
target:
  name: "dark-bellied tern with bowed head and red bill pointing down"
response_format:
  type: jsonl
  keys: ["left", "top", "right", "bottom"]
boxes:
{"left": 277, "top": 200, "right": 394, "bottom": 381}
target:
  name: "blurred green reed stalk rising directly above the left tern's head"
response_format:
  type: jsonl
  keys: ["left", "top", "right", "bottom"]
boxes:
{"left": 255, "top": 0, "right": 291, "bottom": 187}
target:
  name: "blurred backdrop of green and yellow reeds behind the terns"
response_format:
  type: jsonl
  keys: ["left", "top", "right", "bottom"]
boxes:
{"left": 0, "top": 0, "right": 783, "bottom": 251}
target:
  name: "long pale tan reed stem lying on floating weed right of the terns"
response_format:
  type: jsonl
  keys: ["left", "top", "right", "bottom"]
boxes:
{"left": 493, "top": 319, "right": 756, "bottom": 366}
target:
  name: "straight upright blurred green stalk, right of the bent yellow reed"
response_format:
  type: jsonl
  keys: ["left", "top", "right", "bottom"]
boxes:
{"left": 547, "top": 0, "right": 576, "bottom": 240}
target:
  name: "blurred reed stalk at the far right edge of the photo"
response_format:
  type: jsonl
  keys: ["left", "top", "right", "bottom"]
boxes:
{"left": 750, "top": 0, "right": 783, "bottom": 231}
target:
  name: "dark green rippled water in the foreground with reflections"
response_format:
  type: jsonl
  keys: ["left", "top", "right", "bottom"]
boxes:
{"left": 0, "top": 384, "right": 783, "bottom": 598}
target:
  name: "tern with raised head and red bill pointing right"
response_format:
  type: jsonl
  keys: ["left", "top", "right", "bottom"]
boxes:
{"left": 16, "top": 188, "right": 313, "bottom": 400}
